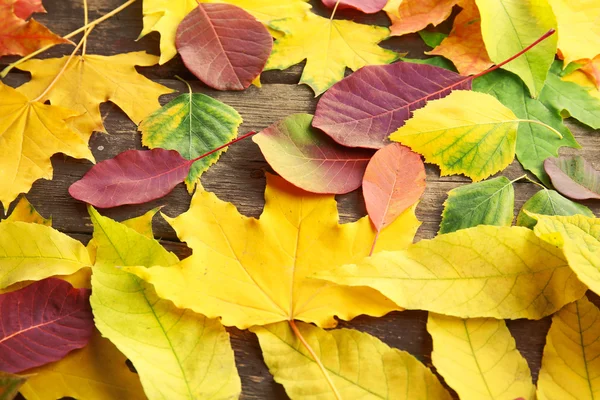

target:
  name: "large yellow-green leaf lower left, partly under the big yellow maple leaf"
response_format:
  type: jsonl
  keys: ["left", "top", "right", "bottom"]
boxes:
{"left": 89, "top": 207, "right": 241, "bottom": 400}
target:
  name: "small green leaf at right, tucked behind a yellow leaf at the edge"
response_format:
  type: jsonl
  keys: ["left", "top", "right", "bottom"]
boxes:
{"left": 517, "top": 189, "right": 594, "bottom": 229}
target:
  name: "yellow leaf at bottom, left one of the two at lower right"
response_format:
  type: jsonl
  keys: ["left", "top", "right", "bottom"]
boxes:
{"left": 427, "top": 313, "right": 535, "bottom": 400}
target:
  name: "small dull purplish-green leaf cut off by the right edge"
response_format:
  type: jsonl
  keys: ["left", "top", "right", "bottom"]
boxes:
{"left": 544, "top": 156, "right": 600, "bottom": 200}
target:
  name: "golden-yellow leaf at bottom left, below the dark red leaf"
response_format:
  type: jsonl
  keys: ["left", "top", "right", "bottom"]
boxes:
{"left": 21, "top": 331, "right": 146, "bottom": 400}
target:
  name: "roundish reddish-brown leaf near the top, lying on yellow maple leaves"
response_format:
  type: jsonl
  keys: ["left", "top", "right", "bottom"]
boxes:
{"left": 176, "top": 4, "right": 273, "bottom": 90}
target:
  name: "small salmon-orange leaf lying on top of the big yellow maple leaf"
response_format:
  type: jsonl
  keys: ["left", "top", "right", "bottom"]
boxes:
{"left": 363, "top": 143, "right": 425, "bottom": 231}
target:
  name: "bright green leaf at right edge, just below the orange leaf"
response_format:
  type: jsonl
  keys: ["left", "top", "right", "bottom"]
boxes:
{"left": 540, "top": 61, "right": 600, "bottom": 129}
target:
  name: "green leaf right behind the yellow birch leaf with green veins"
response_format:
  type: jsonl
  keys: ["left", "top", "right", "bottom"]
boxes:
{"left": 473, "top": 70, "right": 581, "bottom": 186}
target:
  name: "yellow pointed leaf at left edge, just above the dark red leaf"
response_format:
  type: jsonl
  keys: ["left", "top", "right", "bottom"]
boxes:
{"left": 0, "top": 221, "right": 91, "bottom": 289}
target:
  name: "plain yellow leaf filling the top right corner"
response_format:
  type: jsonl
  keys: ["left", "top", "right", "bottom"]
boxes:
{"left": 548, "top": 0, "right": 600, "bottom": 65}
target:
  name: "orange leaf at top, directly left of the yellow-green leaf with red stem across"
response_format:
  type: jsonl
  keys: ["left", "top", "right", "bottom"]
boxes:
{"left": 425, "top": 0, "right": 493, "bottom": 75}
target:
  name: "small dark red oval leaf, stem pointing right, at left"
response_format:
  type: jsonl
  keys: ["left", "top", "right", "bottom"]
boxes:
{"left": 69, "top": 148, "right": 192, "bottom": 208}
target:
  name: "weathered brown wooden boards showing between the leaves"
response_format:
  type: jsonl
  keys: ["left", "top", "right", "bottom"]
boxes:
{"left": 0, "top": 0, "right": 600, "bottom": 399}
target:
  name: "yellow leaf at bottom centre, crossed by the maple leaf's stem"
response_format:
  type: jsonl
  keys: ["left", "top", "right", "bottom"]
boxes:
{"left": 250, "top": 322, "right": 452, "bottom": 400}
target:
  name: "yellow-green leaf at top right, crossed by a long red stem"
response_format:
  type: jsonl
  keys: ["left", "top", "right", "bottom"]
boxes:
{"left": 476, "top": 0, "right": 557, "bottom": 98}
